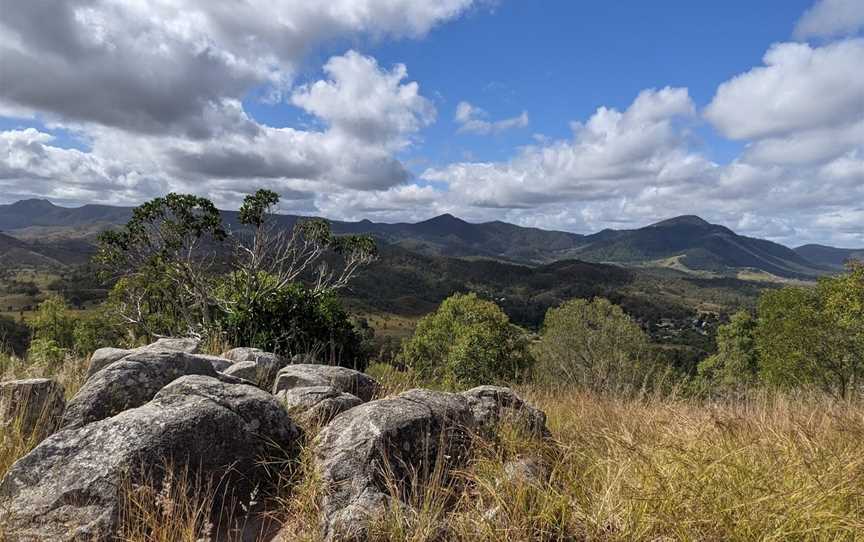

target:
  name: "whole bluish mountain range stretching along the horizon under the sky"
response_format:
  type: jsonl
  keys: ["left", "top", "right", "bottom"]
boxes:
{"left": 0, "top": 199, "right": 864, "bottom": 279}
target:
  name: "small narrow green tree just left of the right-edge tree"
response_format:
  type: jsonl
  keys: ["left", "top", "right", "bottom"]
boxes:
{"left": 699, "top": 311, "right": 759, "bottom": 390}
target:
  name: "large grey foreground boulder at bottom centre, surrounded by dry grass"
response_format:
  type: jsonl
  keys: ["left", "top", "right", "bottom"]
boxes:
{"left": 314, "top": 390, "right": 474, "bottom": 540}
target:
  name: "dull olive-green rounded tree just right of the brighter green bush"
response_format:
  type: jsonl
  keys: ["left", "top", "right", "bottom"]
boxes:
{"left": 534, "top": 298, "right": 656, "bottom": 391}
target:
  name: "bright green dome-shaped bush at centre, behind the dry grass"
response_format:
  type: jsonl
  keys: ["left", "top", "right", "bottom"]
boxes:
{"left": 399, "top": 293, "right": 533, "bottom": 387}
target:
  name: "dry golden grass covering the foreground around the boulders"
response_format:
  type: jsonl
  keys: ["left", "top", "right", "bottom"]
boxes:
{"left": 0, "top": 356, "right": 864, "bottom": 542}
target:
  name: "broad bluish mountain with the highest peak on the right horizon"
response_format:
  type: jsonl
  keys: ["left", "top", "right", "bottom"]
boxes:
{"left": 571, "top": 216, "right": 826, "bottom": 278}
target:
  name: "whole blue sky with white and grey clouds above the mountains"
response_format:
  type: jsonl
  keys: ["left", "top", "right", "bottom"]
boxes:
{"left": 0, "top": 0, "right": 864, "bottom": 247}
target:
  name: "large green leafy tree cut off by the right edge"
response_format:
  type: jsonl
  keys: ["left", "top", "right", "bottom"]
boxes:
{"left": 756, "top": 264, "right": 864, "bottom": 397}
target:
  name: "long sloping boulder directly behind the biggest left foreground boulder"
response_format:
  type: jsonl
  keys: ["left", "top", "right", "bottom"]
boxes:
{"left": 61, "top": 352, "right": 218, "bottom": 429}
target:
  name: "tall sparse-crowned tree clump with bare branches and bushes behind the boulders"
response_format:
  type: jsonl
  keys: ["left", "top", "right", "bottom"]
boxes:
{"left": 96, "top": 190, "right": 377, "bottom": 366}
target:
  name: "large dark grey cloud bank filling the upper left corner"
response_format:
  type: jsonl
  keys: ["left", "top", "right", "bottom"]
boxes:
{"left": 0, "top": 0, "right": 472, "bottom": 138}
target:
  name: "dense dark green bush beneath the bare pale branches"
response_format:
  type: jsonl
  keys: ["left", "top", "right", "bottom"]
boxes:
{"left": 216, "top": 272, "right": 371, "bottom": 370}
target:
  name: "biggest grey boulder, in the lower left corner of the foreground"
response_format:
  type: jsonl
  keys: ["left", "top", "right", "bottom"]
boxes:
{"left": 0, "top": 376, "right": 301, "bottom": 542}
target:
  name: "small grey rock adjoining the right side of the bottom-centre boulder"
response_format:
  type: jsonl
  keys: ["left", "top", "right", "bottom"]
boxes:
{"left": 461, "top": 386, "right": 551, "bottom": 438}
